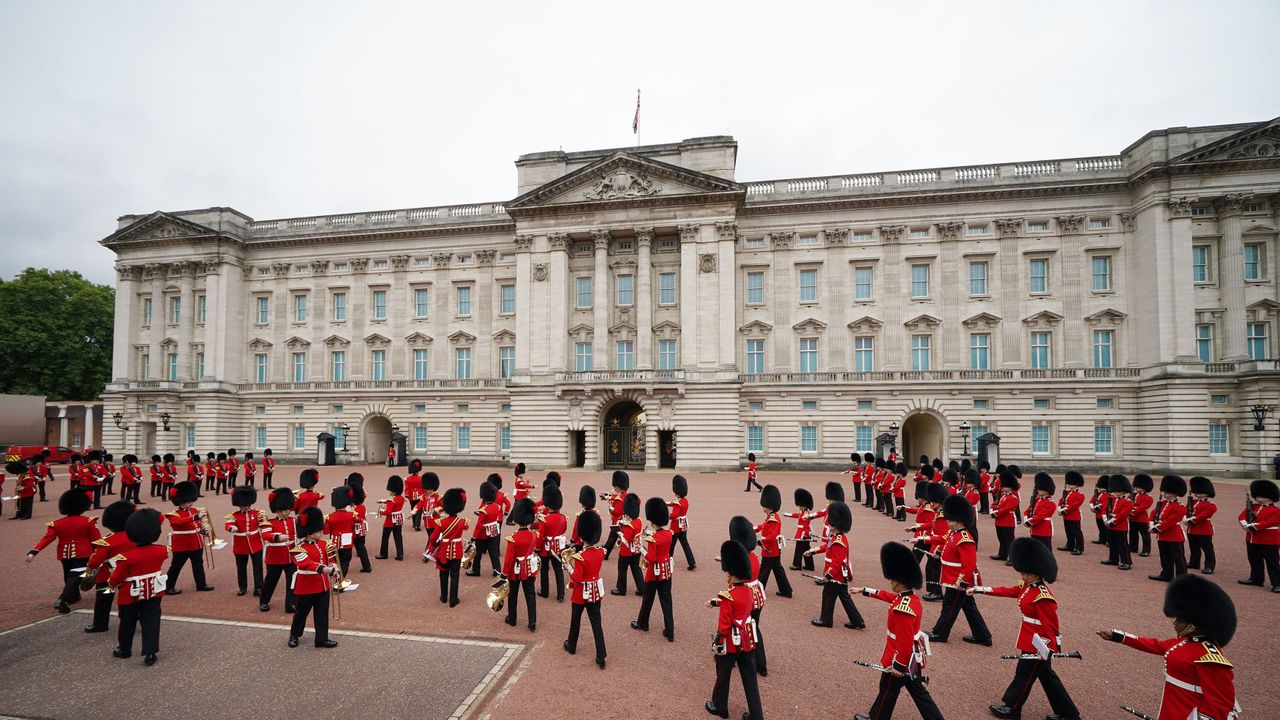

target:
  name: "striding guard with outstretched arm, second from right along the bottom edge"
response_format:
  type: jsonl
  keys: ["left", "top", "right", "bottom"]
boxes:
{"left": 969, "top": 538, "right": 1080, "bottom": 720}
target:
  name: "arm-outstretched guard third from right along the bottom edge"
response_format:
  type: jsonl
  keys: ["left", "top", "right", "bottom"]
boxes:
{"left": 854, "top": 542, "right": 942, "bottom": 720}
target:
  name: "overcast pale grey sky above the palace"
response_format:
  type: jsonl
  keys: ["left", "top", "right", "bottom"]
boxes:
{"left": 0, "top": 0, "right": 1280, "bottom": 282}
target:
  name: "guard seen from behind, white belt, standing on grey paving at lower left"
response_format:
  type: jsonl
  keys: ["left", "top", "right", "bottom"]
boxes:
{"left": 108, "top": 507, "right": 169, "bottom": 665}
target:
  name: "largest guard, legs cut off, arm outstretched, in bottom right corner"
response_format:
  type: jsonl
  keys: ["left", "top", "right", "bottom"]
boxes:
{"left": 1098, "top": 575, "right": 1240, "bottom": 720}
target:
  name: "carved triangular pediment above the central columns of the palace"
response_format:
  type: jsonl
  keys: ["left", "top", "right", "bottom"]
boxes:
{"left": 506, "top": 150, "right": 745, "bottom": 213}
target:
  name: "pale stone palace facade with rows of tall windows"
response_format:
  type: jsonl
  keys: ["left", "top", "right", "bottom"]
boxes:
{"left": 102, "top": 119, "right": 1280, "bottom": 474}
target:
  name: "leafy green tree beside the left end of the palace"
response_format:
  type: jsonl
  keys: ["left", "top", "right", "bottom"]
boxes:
{"left": 0, "top": 268, "right": 115, "bottom": 400}
